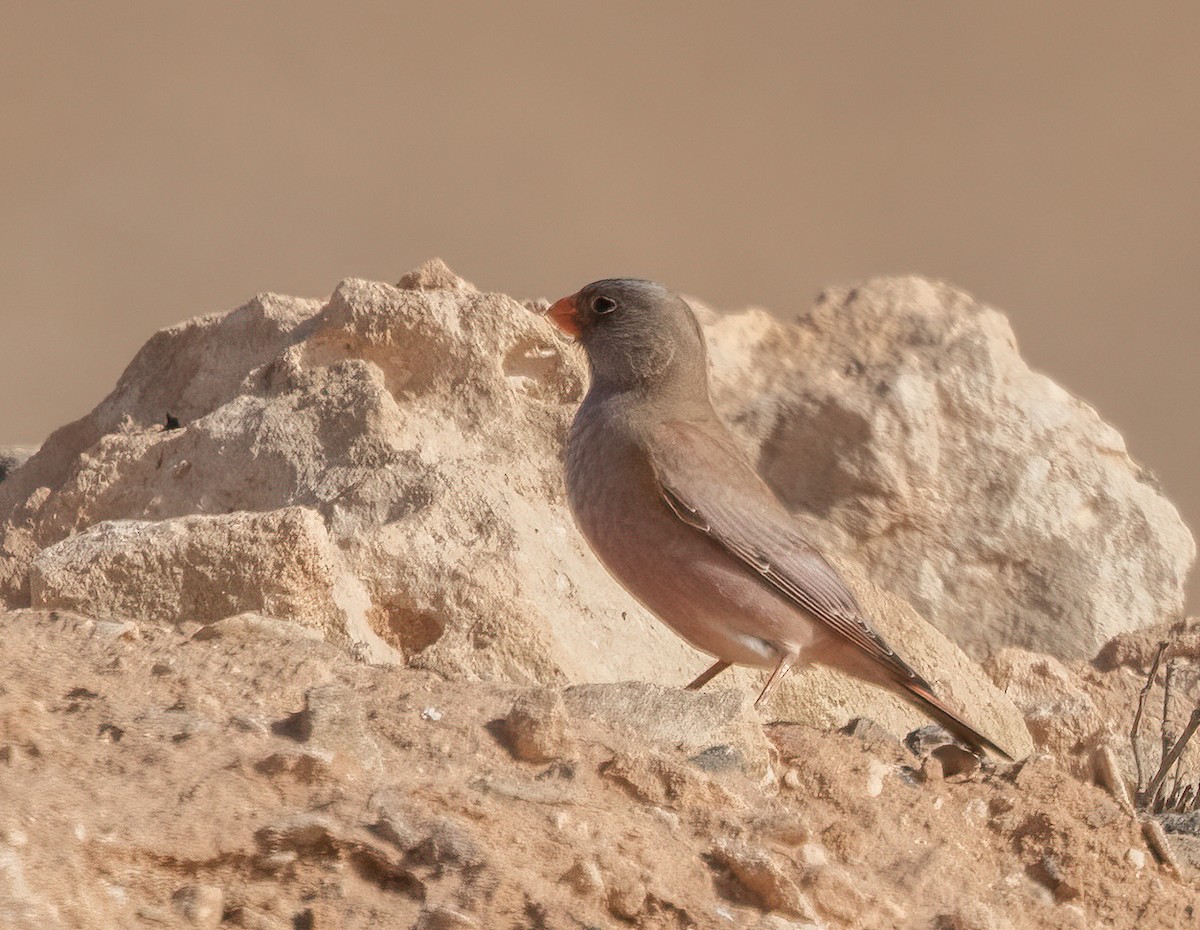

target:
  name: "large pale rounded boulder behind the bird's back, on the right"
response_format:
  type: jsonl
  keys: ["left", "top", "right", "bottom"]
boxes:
{"left": 708, "top": 277, "right": 1195, "bottom": 658}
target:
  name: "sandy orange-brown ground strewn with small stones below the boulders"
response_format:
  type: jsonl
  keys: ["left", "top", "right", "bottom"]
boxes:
{"left": 0, "top": 611, "right": 1200, "bottom": 930}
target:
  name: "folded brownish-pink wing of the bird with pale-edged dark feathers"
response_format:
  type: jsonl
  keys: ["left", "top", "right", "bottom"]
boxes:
{"left": 649, "top": 420, "right": 930, "bottom": 690}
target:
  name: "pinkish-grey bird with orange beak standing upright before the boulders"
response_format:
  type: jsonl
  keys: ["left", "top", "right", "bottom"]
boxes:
{"left": 545, "top": 278, "right": 1010, "bottom": 758}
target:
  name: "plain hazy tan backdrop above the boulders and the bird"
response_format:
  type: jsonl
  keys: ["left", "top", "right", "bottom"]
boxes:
{"left": 0, "top": 0, "right": 1200, "bottom": 604}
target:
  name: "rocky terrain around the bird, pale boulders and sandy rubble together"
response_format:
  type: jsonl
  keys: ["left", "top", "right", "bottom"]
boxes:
{"left": 0, "top": 263, "right": 1200, "bottom": 930}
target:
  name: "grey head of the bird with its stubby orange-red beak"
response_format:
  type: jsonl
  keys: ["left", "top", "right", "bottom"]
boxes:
{"left": 547, "top": 277, "right": 708, "bottom": 401}
